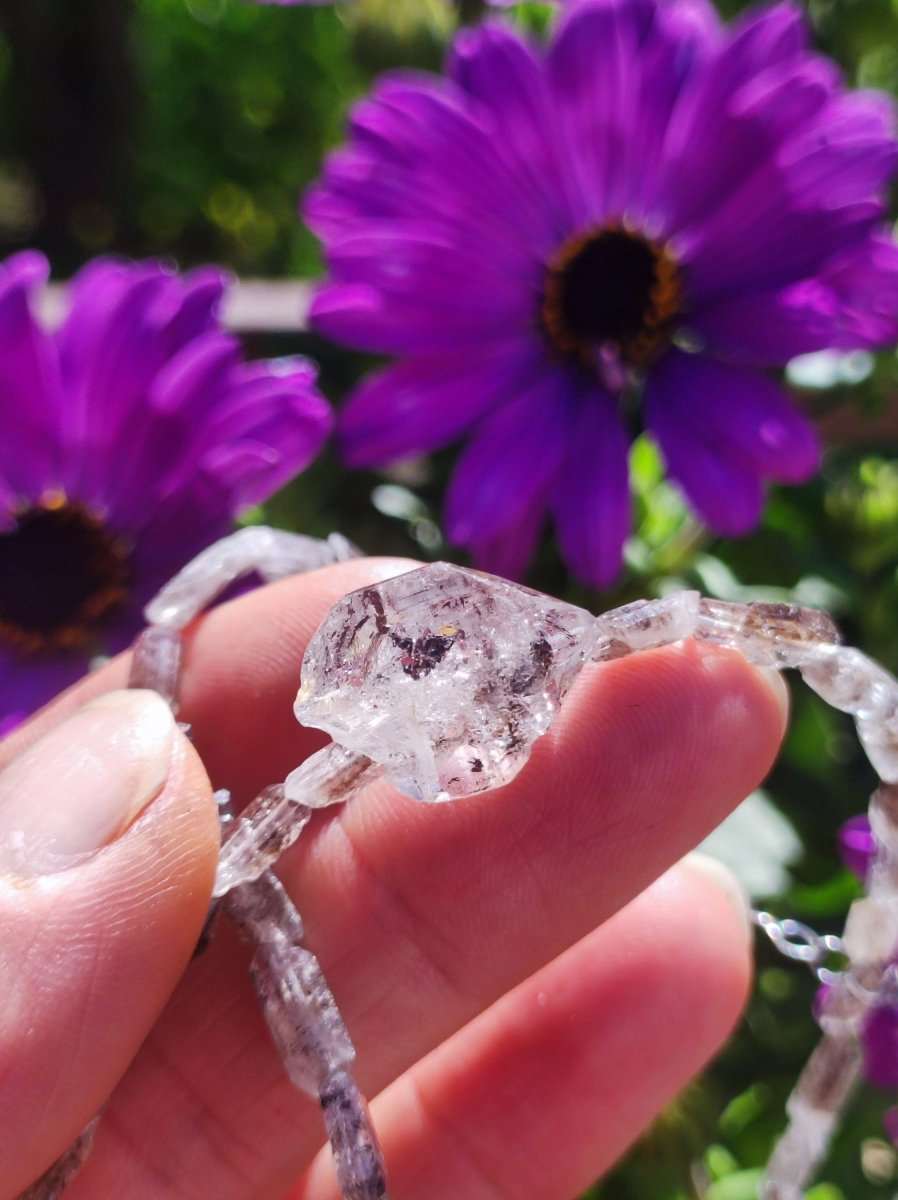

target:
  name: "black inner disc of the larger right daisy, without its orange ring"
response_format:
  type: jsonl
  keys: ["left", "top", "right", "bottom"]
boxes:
{"left": 558, "top": 229, "right": 657, "bottom": 343}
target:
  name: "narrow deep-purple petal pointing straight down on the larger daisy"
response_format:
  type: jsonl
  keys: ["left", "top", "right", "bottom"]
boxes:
{"left": 552, "top": 389, "right": 630, "bottom": 588}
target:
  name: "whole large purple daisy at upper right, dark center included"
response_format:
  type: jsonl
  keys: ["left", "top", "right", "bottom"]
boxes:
{"left": 305, "top": 0, "right": 898, "bottom": 586}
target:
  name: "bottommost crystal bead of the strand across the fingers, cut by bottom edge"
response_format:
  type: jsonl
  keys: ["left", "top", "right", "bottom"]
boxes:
{"left": 319, "top": 1070, "right": 387, "bottom": 1200}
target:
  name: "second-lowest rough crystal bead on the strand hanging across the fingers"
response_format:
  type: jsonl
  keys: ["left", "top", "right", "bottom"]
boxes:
{"left": 250, "top": 942, "right": 355, "bottom": 1096}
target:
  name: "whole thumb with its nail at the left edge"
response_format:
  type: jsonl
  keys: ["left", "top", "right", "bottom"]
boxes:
{"left": 0, "top": 691, "right": 218, "bottom": 1198}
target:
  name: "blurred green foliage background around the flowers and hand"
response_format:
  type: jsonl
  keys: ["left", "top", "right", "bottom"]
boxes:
{"left": 0, "top": 0, "right": 898, "bottom": 1200}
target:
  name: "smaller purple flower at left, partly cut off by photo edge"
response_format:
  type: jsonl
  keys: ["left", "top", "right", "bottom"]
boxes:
{"left": 0, "top": 252, "right": 330, "bottom": 721}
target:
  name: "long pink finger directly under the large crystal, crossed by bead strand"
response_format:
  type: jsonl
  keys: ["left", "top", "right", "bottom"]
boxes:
{"left": 59, "top": 595, "right": 784, "bottom": 1200}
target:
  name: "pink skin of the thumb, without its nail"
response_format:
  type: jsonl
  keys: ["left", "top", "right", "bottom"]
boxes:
{"left": 0, "top": 715, "right": 218, "bottom": 1195}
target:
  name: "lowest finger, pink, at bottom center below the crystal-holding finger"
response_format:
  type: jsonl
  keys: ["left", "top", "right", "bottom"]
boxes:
{"left": 297, "top": 856, "right": 750, "bottom": 1200}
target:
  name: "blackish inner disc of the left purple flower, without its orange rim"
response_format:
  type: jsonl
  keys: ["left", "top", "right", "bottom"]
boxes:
{"left": 0, "top": 508, "right": 124, "bottom": 641}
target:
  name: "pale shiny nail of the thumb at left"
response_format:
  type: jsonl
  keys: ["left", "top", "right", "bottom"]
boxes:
{"left": 0, "top": 689, "right": 175, "bottom": 878}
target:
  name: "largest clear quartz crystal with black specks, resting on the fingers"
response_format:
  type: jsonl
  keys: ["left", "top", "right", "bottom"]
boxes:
{"left": 291, "top": 563, "right": 595, "bottom": 800}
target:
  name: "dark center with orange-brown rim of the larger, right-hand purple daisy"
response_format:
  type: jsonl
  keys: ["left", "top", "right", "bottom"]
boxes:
{"left": 541, "top": 224, "right": 682, "bottom": 367}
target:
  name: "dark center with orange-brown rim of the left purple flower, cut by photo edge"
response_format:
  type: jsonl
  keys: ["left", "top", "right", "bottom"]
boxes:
{"left": 0, "top": 497, "right": 131, "bottom": 654}
